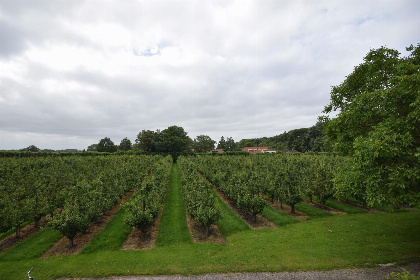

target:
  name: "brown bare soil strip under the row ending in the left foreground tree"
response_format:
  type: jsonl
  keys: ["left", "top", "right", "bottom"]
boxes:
{"left": 40, "top": 190, "right": 134, "bottom": 258}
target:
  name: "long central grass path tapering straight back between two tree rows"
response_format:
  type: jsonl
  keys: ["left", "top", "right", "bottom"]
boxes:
{"left": 157, "top": 163, "right": 191, "bottom": 247}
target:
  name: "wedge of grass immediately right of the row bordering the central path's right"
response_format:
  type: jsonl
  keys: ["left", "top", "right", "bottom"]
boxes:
{"left": 216, "top": 191, "right": 251, "bottom": 236}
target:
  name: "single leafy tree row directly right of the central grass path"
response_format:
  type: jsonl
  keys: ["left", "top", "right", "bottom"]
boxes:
{"left": 178, "top": 157, "right": 221, "bottom": 237}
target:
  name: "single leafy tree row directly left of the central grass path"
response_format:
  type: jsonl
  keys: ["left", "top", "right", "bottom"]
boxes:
{"left": 124, "top": 156, "right": 172, "bottom": 236}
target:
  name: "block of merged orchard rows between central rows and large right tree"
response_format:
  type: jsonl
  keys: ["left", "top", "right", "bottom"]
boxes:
{"left": 196, "top": 154, "right": 345, "bottom": 217}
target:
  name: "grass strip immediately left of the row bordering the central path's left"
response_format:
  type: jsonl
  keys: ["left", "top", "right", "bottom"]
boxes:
{"left": 80, "top": 208, "right": 132, "bottom": 254}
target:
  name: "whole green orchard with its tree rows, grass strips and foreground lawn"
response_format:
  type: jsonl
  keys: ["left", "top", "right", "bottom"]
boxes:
{"left": 0, "top": 154, "right": 420, "bottom": 279}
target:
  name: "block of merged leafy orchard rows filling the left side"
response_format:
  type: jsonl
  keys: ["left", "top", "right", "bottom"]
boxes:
{"left": 0, "top": 156, "right": 154, "bottom": 243}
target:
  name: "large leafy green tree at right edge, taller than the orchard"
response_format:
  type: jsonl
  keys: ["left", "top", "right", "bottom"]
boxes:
{"left": 323, "top": 44, "right": 420, "bottom": 205}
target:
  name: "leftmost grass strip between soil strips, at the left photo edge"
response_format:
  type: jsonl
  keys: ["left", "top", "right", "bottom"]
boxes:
{"left": 0, "top": 229, "right": 62, "bottom": 261}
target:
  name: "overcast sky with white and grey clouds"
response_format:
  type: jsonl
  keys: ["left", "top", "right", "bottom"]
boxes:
{"left": 0, "top": 0, "right": 420, "bottom": 150}
